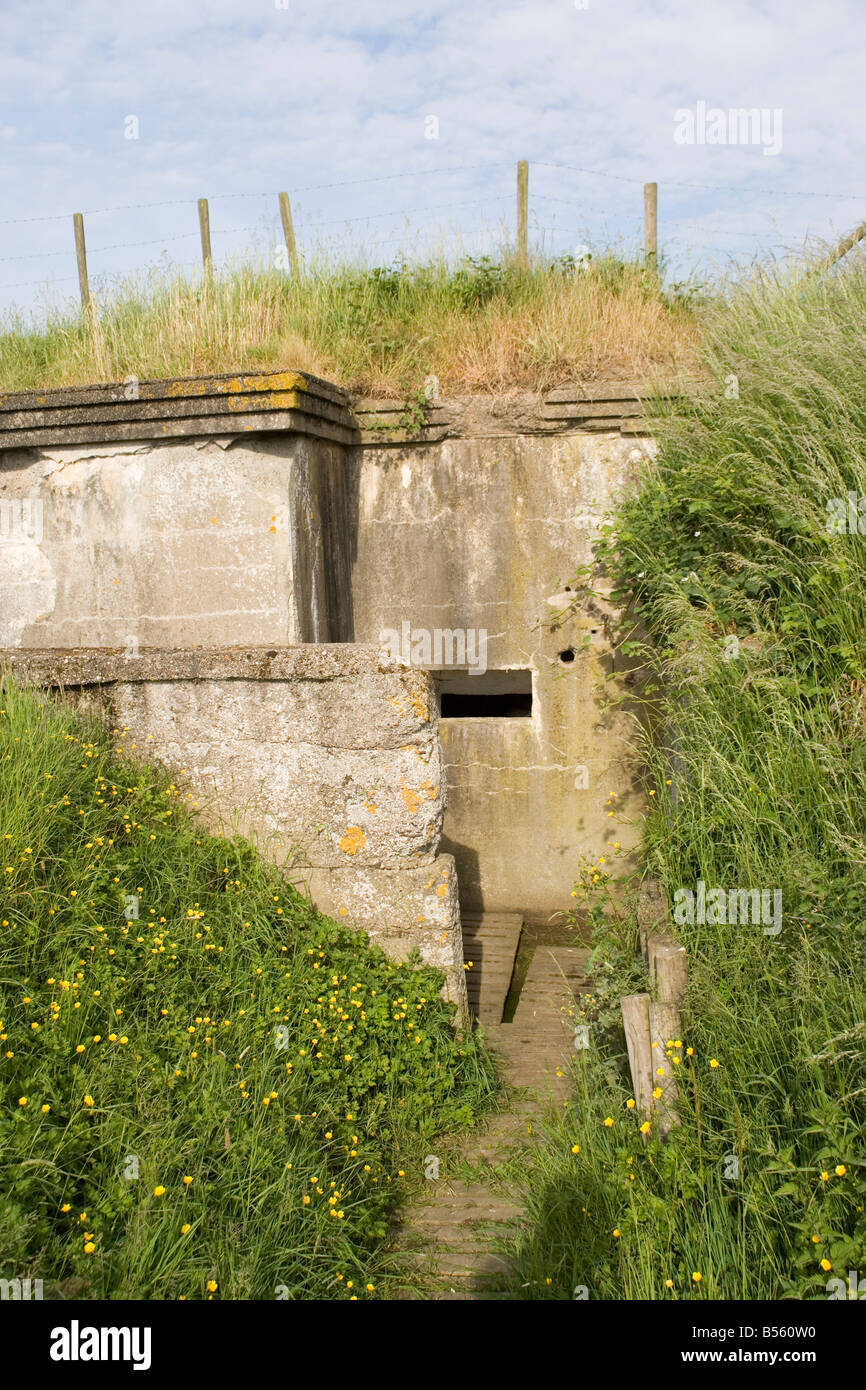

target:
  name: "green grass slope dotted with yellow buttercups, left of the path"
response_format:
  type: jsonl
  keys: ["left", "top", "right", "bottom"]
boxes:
{"left": 0, "top": 676, "right": 493, "bottom": 1300}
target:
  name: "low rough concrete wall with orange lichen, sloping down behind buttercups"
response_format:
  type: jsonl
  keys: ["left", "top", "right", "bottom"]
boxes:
{"left": 8, "top": 644, "right": 466, "bottom": 1016}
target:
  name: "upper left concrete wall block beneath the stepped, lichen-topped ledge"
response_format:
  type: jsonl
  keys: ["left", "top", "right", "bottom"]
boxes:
{"left": 0, "top": 434, "right": 352, "bottom": 648}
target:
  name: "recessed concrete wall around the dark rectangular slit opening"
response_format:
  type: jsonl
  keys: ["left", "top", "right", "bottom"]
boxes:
{"left": 352, "top": 432, "right": 648, "bottom": 913}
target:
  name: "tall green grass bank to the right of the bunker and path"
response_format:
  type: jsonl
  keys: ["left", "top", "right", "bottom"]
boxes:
{"left": 497, "top": 258, "right": 866, "bottom": 1300}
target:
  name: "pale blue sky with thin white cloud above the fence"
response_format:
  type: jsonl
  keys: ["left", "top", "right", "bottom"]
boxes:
{"left": 0, "top": 0, "right": 866, "bottom": 318}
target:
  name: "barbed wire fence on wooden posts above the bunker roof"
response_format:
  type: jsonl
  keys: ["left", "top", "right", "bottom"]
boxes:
{"left": 0, "top": 160, "right": 866, "bottom": 309}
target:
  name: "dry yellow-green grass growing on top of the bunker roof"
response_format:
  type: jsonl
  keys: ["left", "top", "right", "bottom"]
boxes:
{"left": 0, "top": 253, "right": 698, "bottom": 398}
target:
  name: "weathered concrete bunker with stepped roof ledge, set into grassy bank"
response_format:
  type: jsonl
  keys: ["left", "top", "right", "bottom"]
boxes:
{"left": 0, "top": 373, "right": 652, "bottom": 1028}
